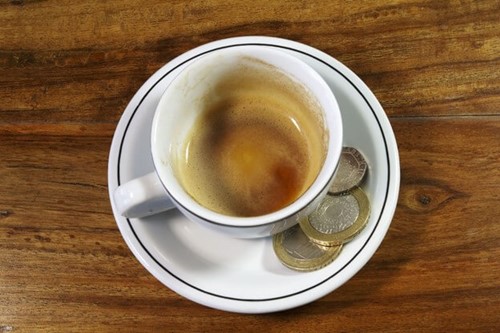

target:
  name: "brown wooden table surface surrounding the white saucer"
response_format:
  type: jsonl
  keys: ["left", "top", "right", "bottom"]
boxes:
{"left": 0, "top": 0, "right": 500, "bottom": 333}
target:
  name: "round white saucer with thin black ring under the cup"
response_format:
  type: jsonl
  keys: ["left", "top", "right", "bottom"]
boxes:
{"left": 108, "top": 37, "right": 400, "bottom": 313}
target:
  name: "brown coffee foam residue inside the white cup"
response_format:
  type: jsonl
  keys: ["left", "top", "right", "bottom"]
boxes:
{"left": 177, "top": 58, "right": 326, "bottom": 216}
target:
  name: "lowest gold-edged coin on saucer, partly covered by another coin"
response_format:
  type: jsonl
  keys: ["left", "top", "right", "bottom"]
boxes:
{"left": 273, "top": 224, "right": 342, "bottom": 272}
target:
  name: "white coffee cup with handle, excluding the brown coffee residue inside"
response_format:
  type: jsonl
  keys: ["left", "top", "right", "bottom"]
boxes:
{"left": 114, "top": 45, "right": 343, "bottom": 238}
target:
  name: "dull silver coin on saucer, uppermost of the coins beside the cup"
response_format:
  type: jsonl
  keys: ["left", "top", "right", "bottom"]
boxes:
{"left": 329, "top": 147, "right": 368, "bottom": 194}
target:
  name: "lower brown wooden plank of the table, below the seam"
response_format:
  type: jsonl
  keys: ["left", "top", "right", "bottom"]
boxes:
{"left": 0, "top": 117, "right": 500, "bottom": 332}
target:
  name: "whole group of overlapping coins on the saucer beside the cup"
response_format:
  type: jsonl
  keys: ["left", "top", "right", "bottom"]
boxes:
{"left": 273, "top": 147, "right": 370, "bottom": 271}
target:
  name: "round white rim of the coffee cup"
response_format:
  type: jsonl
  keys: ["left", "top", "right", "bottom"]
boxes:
{"left": 151, "top": 45, "right": 343, "bottom": 228}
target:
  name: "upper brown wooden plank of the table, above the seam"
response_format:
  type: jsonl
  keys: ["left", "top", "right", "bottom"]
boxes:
{"left": 0, "top": 1, "right": 500, "bottom": 124}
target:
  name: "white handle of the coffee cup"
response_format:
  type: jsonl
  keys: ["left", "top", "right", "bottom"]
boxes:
{"left": 113, "top": 172, "right": 175, "bottom": 218}
